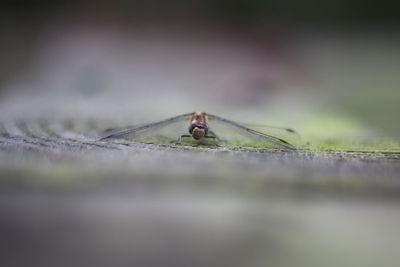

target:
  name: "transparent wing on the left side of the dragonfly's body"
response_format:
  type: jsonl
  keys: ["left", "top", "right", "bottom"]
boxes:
{"left": 100, "top": 113, "right": 192, "bottom": 143}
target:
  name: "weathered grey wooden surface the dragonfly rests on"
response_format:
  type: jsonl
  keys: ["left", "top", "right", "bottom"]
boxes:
{"left": 0, "top": 121, "right": 400, "bottom": 267}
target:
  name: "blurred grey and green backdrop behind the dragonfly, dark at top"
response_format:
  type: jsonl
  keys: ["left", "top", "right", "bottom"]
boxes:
{"left": 0, "top": 0, "right": 400, "bottom": 137}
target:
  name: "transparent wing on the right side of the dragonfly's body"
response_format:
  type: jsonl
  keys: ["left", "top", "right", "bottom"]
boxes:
{"left": 207, "top": 114, "right": 296, "bottom": 149}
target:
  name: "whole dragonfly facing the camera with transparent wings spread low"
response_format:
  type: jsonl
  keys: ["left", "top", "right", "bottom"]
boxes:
{"left": 99, "top": 112, "right": 297, "bottom": 150}
